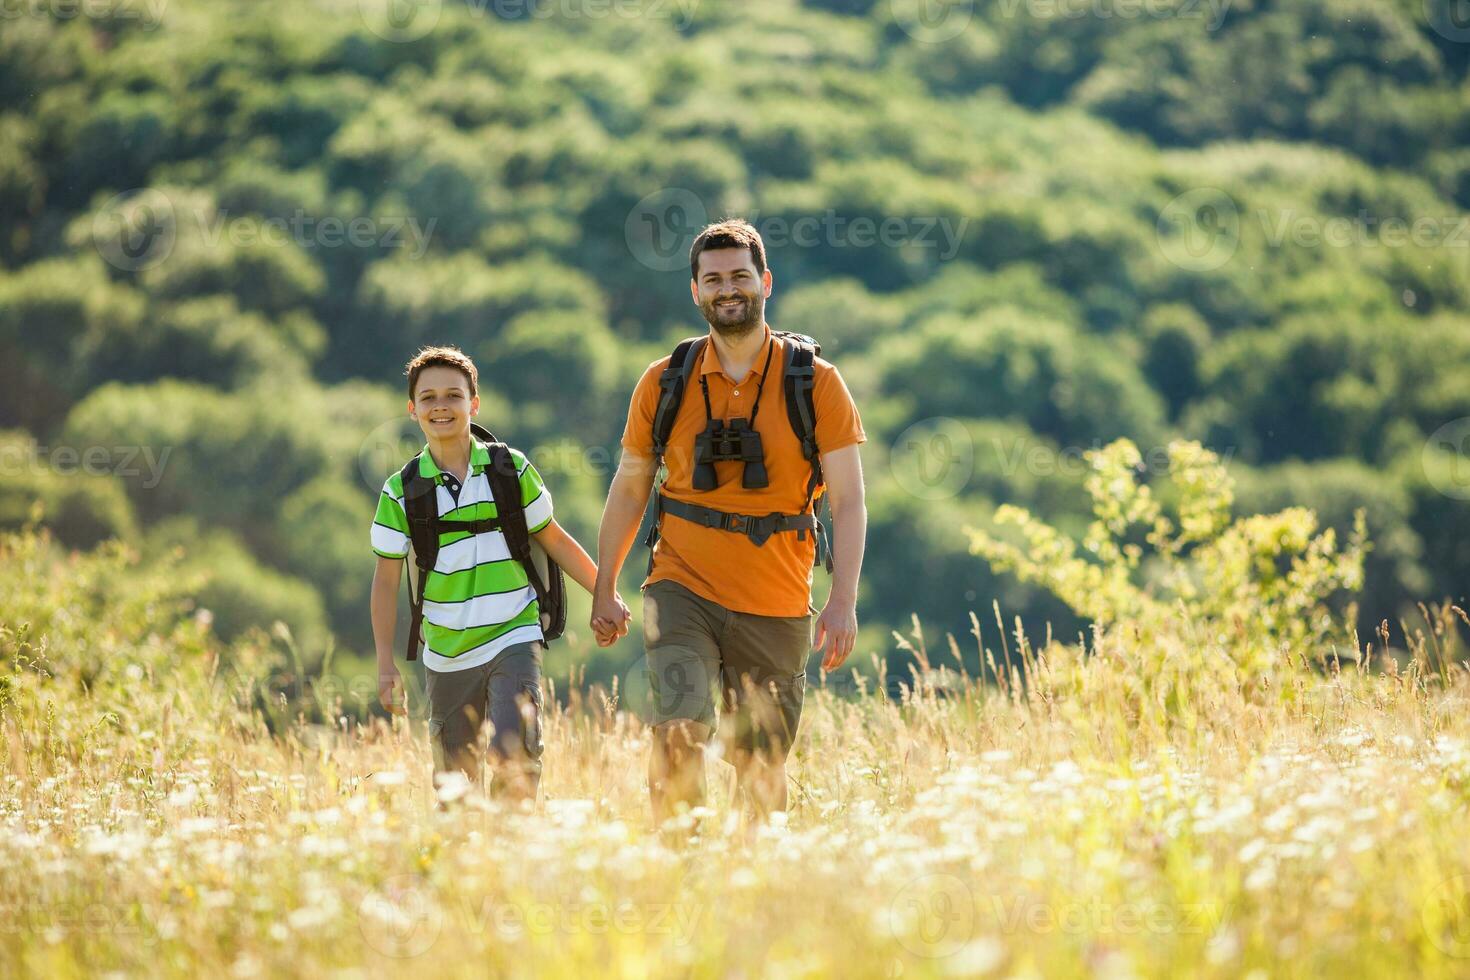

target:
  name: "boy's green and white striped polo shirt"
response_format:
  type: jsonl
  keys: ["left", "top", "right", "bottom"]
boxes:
{"left": 372, "top": 439, "right": 551, "bottom": 671}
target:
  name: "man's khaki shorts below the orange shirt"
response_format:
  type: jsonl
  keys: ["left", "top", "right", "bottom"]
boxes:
{"left": 644, "top": 580, "right": 813, "bottom": 758}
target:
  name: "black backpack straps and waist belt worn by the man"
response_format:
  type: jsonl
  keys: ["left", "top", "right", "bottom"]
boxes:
{"left": 644, "top": 331, "right": 832, "bottom": 573}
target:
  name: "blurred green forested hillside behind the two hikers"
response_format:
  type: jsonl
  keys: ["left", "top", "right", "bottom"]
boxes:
{"left": 0, "top": 0, "right": 1470, "bottom": 690}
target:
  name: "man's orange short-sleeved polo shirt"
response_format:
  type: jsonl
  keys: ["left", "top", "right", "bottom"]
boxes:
{"left": 623, "top": 326, "right": 867, "bottom": 616}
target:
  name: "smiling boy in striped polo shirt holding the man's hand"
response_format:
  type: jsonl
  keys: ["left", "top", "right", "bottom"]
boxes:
{"left": 372, "top": 347, "right": 628, "bottom": 802}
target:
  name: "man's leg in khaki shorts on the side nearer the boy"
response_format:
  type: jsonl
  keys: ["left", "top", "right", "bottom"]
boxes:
{"left": 644, "top": 582, "right": 729, "bottom": 824}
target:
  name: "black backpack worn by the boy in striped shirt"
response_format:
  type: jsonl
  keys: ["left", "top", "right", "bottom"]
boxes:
{"left": 401, "top": 423, "right": 566, "bottom": 660}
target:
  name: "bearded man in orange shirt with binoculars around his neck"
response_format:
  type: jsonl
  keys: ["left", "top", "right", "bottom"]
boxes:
{"left": 592, "top": 220, "right": 867, "bottom": 823}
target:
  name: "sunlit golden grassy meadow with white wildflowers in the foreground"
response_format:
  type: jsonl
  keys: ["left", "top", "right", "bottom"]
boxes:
{"left": 0, "top": 447, "right": 1470, "bottom": 977}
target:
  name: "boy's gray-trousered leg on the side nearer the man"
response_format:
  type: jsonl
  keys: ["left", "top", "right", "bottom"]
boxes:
{"left": 487, "top": 642, "right": 544, "bottom": 802}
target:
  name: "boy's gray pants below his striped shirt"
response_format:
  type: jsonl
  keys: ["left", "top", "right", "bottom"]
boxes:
{"left": 425, "top": 642, "right": 542, "bottom": 799}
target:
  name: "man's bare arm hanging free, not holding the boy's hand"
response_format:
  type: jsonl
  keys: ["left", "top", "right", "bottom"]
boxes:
{"left": 813, "top": 444, "right": 867, "bottom": 670}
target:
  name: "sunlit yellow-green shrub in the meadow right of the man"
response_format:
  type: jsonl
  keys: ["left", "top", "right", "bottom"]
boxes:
{"left": 970, "top": 439, "right": 1367, "bottom": 674}
